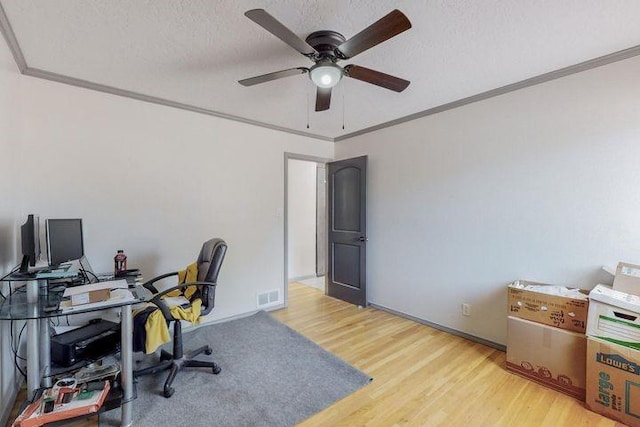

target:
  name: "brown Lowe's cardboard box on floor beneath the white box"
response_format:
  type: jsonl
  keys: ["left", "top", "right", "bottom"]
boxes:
{"left": 586, "top": 337, "right": 640, "bottom": 426}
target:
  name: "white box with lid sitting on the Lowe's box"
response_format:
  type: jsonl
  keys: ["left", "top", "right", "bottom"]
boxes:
{"left": 587, "top": 285, "right": 640, "bottom": 350}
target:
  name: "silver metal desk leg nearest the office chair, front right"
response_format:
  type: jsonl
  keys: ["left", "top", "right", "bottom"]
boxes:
{"left": 120, "top": 305, "right": 133, "bottom": 427}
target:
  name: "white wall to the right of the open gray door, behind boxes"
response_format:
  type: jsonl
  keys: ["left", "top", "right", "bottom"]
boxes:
{"left": 336, "top": 58, "right": 640, "bottom": 344}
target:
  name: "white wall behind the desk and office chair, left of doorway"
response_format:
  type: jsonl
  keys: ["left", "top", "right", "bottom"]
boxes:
{"left": 20, "top": 77, "right": 333, "bottom": 319}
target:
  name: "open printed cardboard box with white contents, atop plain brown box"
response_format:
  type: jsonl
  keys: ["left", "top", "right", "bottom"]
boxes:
{"left": 508, "top": 280, "right": 589, "bottom": 333}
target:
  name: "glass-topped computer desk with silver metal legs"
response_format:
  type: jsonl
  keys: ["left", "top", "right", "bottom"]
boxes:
{"left": 0, "top": 273, "right": 146, "bottom": 426}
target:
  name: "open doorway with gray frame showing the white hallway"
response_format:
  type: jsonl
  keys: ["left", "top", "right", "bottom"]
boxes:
{"left": 284, "top": 153, "right": 329, "bottom": 305}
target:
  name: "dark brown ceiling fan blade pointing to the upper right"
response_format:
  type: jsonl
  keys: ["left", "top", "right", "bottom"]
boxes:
{"left": 337, "top": 9, "right": 411, "bottom": 59}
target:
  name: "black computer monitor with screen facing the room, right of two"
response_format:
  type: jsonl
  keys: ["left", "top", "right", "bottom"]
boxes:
{"left": 46, "top": 218, "right": 84, "bottom": 265}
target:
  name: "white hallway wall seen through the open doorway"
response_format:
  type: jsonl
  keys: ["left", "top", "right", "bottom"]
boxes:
{"left": 287, "top": 159, "right": 317, "bottom": 280}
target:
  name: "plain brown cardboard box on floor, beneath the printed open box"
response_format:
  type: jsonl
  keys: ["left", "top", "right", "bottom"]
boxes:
{"left": 506, "top": 316, "right": 587, "bottom": 400}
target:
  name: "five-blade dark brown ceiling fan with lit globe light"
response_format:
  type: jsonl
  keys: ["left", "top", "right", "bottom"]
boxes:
{"left": 238, "top": 9, "right": 411, "bottom": 111}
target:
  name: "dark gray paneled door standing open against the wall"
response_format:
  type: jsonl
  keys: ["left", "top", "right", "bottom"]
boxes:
{"left": 327, "top": 156, "right": 367, "bottom": 307}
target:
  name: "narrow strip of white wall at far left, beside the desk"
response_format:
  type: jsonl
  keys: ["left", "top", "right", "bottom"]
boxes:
{"left": 0, "top": 42, "right": 26, "bottom": 425}
